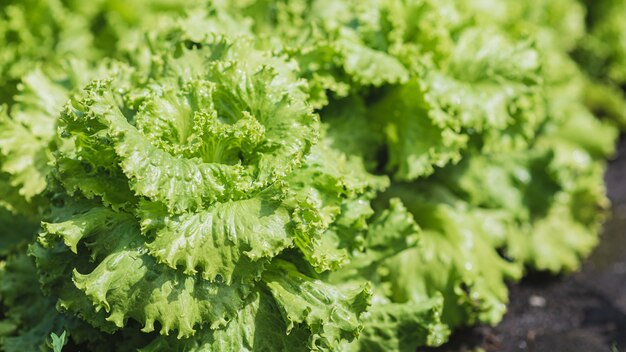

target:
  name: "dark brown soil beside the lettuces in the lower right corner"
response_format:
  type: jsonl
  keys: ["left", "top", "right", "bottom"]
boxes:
{"left": 427, "top": 138, "right": 626, "bottom": 352}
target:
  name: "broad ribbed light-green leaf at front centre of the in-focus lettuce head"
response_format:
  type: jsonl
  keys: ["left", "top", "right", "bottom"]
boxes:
{"left": 138, "top": 190, "right": 293, "bottom": 284}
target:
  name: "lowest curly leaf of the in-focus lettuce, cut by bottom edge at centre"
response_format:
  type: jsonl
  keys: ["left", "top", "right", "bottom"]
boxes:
{"left": 140, "top": 259, "right": 371, "bottom": 351}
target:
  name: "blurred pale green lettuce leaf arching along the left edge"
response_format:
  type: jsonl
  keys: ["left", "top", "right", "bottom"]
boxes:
{"left": 0, "top": 59, "right": 118, "bottom": 218}
